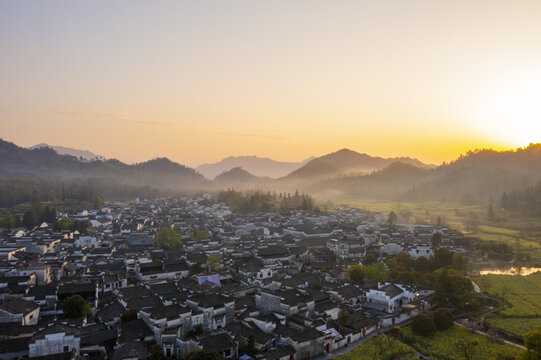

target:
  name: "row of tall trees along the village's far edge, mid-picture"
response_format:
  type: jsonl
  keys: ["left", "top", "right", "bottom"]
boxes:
{"left": 218, "top": 189, "right": 314, "bottom": 212}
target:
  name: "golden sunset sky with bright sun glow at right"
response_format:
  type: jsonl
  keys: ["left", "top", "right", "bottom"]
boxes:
{"left": 0, "top": 0, "right": 541, "bottom": 166}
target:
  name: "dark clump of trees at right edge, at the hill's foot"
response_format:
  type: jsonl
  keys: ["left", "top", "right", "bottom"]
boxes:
{"left": 500, "top": 182, "right": 541, "bottom": 216}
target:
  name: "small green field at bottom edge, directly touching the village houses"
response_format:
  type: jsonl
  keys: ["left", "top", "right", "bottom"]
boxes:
{"left": 336, "top": 339, "right": 417, "bottom": 360}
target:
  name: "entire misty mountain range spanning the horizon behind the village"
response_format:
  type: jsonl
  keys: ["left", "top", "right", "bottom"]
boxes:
{"left": 0, "top": 140, "right": 541, "bottom": 203}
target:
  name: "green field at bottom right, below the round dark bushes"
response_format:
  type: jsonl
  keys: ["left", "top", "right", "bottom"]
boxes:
{"left": 403, "top": 325, "right": 524, "bottom": 360}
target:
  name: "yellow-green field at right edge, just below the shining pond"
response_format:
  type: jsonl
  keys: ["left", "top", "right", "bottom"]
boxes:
{"left": 475, "top": 273, "right": 541, "bottom": 338}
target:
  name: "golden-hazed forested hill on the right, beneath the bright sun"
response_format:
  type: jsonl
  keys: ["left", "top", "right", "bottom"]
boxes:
{"left": 307, "top": 144, "right": 541, "bottom": 203}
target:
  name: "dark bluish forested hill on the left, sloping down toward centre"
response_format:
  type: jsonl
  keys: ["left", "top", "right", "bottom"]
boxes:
{"left": 0, "top": 139, "right": 210, "bottom": 190}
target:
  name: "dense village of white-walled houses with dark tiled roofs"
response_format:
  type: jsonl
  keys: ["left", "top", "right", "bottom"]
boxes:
{"left": 0, "top": 196, "right": 468, "bottom": 360}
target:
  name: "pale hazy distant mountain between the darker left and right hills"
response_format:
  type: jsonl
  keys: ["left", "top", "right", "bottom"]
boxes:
{"left": 196, "top": 156, "right": 313, "bottom": 179}
